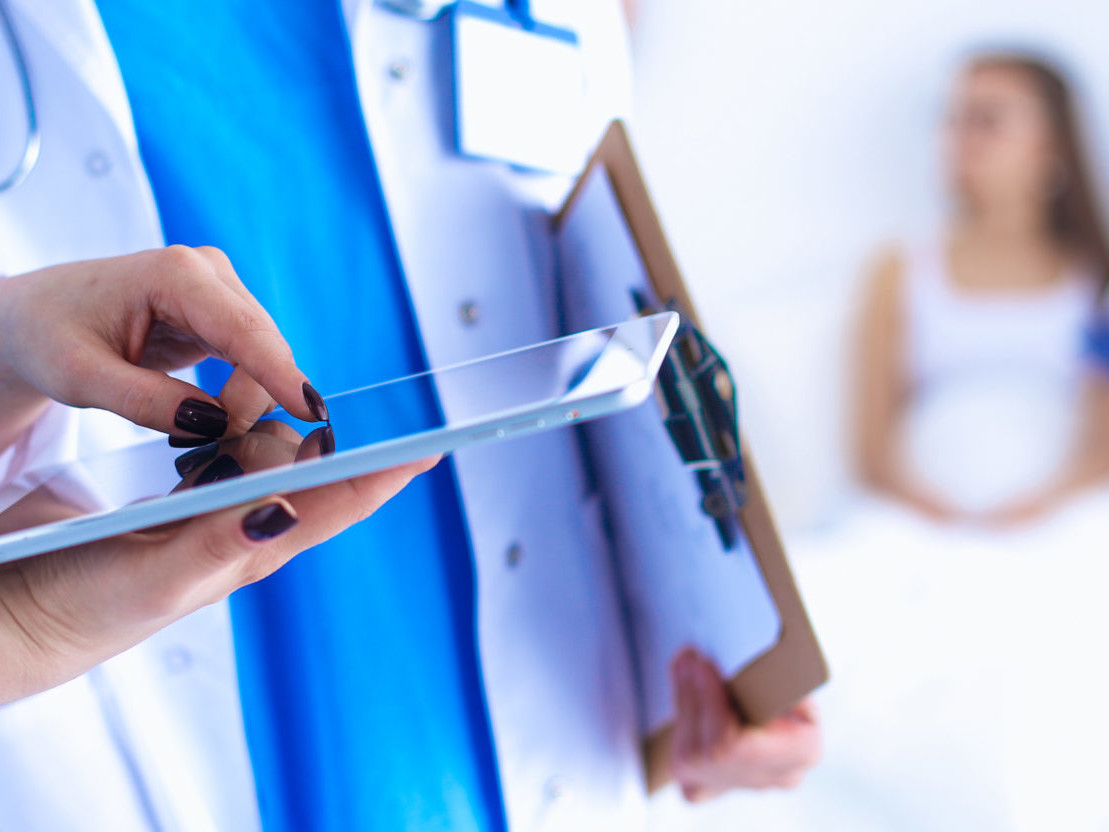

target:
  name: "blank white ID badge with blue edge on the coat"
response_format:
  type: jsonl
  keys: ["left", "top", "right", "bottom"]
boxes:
{"left": 451, "top": 0, "right": 589, "bottom": 174}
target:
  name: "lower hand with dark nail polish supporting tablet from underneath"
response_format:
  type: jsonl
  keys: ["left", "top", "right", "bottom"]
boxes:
{"left": 0, "top": 457, "right": 436, "bottom": 703}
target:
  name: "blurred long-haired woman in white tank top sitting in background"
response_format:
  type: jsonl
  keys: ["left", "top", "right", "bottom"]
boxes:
{"left": 856, "top": 53, "right": 1109, "bottom": 524}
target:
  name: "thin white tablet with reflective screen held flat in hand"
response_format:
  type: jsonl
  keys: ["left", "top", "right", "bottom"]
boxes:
{"left": 0, "top": 313, "right": 678, "bottom": 562}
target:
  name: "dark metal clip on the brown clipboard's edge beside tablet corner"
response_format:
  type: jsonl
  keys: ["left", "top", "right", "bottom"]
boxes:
{"left": 633, "top": 292, "right": 747, "bottom": 551}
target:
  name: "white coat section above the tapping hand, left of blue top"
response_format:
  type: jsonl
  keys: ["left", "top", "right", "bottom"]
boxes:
{"left": 0, "top": 0, "right": 163, "bottom": 274}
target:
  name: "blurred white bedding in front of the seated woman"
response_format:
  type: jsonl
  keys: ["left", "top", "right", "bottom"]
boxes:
{"left": 653, "top": 493, "right": 1109, "bottom": 832}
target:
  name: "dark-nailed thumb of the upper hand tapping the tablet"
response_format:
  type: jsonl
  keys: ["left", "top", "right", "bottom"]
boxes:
{"left": 65, "top": 349, "right": 230, "bottom": 439}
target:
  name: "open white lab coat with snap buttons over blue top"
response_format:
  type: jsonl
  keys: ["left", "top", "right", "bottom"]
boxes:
{"left": 0, "top": 0, "right": 645, "bottom": 832}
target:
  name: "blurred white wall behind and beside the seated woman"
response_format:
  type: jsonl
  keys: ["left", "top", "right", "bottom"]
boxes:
{"left": 633, "top": 0, "right": 1109, "bottom": 528}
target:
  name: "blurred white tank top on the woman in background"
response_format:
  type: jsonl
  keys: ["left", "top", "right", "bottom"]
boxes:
{"left": 904, "top": 246, "right": 1096, "bottom": 511}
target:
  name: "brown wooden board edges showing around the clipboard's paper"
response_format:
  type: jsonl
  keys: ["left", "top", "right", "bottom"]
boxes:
{"left": 556, "top": 121, "right": 828, "bottom": 792}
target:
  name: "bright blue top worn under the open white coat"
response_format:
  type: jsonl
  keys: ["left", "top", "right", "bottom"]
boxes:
{"left": 99, "top": 0, "right": 505, "bottom": 832}
